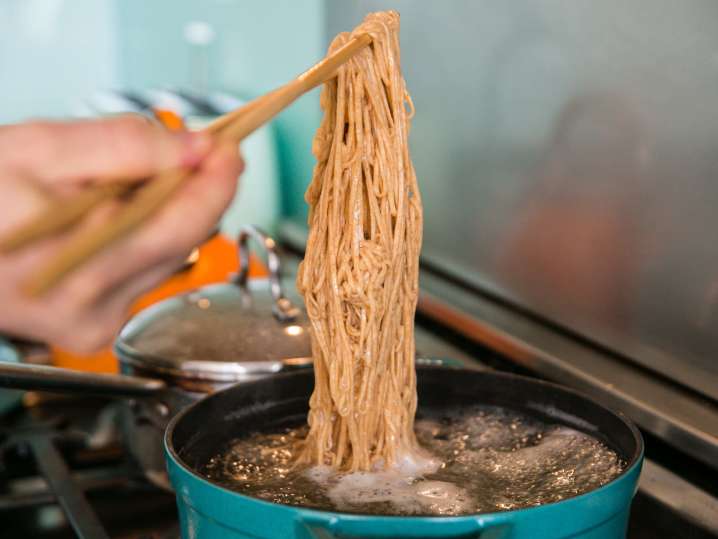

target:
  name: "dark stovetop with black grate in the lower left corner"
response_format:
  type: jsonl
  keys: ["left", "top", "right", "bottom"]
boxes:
{"left": 0, "top": 395, "right": 180, "bottom": 539}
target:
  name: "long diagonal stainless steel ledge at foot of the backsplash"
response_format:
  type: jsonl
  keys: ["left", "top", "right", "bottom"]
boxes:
{"left": 418, "top": 271, "right": 718, "bottom": 468}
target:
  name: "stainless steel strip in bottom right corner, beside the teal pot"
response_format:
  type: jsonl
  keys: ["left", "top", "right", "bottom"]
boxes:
{"left": 639, "top": 459, "right": 718, "bottom": 535}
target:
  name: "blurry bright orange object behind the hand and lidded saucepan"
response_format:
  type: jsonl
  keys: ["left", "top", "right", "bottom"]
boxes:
{"left": 50, "top": 234, "right": 268, "bottom": 372}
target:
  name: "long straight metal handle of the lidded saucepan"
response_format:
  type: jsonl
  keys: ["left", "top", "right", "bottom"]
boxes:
{"left": 0, "top": 362, "right": 166, "bottom": 397}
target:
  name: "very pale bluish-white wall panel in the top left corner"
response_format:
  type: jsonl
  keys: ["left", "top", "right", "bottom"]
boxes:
{"left": 0, "top": 0, "right": 119, "bottom": 123}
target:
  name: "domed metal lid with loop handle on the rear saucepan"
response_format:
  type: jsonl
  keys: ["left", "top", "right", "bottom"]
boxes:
{"left": 115, "top": 227, "right": 311, "bottom": 382}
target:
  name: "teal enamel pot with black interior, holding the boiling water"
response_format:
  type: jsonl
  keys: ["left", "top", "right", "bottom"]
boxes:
{"left": 165, "top": 368, "right": 643, "bottom": 539}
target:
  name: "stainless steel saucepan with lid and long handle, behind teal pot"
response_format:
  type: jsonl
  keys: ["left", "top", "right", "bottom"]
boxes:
{"left": 0, "top": 226, "right": 312, "bottom": 489}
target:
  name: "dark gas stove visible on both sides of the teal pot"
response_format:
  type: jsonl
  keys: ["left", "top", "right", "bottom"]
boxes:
{"left": 0, "top": 322, "right": 718, "bottom": 539}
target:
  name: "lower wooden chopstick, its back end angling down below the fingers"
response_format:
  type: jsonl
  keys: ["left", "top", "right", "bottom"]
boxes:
{"left": 24, "top": 34, "right": 371, "bottom": 296}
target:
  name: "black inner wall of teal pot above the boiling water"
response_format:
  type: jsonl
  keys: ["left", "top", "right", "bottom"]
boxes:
{"left": 172, "top": 367, "right": 642, "bottom": 478}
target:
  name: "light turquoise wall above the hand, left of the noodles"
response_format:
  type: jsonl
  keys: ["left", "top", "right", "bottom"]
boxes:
{"left": 115, "top": 0, "right": 324, "bottom": 218}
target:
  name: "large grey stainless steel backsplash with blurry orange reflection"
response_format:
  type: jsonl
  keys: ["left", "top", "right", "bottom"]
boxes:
{"left": 324, "top": 0, "right": 718, "bottom": 399}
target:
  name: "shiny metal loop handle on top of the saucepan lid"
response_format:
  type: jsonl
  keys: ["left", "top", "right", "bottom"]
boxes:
{"left": 235, "top": 225, "right": 300, "bottom": 322}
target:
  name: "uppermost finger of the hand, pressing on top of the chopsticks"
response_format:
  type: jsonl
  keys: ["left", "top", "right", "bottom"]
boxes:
{"left": 0, "top": 115, "right": 212, "bottom": 183}
